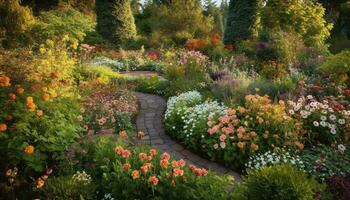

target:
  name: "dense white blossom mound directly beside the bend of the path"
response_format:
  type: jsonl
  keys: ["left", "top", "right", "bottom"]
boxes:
{"left": 164, "top": 91, "right": 202, "bottom": 119}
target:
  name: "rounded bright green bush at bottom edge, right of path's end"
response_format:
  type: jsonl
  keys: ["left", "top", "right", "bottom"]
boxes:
{"left": 234, "top": 165, "right": 320, "bottom": 200}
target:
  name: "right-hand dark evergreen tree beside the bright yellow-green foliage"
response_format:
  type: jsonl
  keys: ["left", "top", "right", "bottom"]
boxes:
{"left": 224, "top": 0, "right": 259, "bottom": 44}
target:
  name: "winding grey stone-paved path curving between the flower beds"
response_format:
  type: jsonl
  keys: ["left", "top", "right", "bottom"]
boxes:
{"left": 135, "top": 92, "right": 240, "bottom": 181}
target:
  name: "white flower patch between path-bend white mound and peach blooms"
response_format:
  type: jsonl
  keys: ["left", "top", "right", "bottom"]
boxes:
{"left": 182, "top": 101, "right": 227, "bottom": 137}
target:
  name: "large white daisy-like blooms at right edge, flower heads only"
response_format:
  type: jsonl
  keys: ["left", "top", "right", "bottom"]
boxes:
{"left": 287, "top": 95, "right": 350, "bottom": 135}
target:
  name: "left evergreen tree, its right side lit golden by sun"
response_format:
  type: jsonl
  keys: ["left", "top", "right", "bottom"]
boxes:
{"left": 96, "top": 0, "right": 136, "bottom": 46}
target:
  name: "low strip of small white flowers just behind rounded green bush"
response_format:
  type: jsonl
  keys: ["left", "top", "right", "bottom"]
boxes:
{"left": 245, "top": 150, "right": 305, "bottom": 169}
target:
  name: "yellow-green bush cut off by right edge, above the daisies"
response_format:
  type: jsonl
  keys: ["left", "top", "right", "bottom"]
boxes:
{"left": 319, "top": 51, "right": 350, "bottom": 86}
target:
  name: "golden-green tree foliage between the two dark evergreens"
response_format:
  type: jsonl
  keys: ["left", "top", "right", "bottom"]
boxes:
{"left": 145, "top": 0, "right": 213, "bottom": 45}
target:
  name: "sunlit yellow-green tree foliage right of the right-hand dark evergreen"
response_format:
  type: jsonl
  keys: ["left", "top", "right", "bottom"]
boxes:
{"left": 261, "top": 0, "right": 332, "bottom": 46}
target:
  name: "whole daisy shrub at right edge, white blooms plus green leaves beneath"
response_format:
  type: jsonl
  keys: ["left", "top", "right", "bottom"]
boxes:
{"left": 288, "top": 95, "right": 350, "bottom": 144}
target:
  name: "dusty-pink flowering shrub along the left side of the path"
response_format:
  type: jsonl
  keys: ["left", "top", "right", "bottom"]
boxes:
{"left": 81, "top": 91, "right": 137, "bottom": 131}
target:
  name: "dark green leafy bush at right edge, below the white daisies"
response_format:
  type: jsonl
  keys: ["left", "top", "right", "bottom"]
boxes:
{"left": 301, "top": 144, "right": 350, "bottom": 181}
